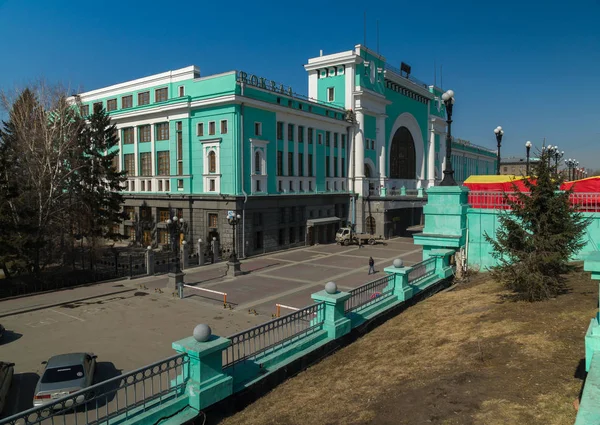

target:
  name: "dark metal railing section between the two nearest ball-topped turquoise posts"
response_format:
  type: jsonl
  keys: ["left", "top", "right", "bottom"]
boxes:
{"left": 223, "top": 302, "right": 325, "bottom": 369}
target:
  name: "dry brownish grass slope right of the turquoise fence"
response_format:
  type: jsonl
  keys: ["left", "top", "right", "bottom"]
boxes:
{"left": 217, "top": 271, "right": 598, "bottom": 425}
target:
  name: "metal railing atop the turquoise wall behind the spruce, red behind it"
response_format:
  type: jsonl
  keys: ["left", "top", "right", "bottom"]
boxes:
{"left": 468, "top": 190, "right": 600, "bottom": 212}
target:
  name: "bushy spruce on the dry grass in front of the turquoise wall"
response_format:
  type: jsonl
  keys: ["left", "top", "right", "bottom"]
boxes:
{"left": 484, "top": 147, "right": 589, "bottom": 301}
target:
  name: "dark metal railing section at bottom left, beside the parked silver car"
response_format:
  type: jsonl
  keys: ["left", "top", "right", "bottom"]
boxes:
{"left": 0, "top": 354, "right": 189, "bottom": 425}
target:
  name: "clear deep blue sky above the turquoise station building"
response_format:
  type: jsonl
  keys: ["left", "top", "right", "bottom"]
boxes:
{"left": 0, "top": 0, "right": 600, "bottom": 169}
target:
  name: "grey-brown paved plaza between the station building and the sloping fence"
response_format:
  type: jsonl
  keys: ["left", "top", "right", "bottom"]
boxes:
{"left": 0, "top": 238, "right": 421, "bottom": 413}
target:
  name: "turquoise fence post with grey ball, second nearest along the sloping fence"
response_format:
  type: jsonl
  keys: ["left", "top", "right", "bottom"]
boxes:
{"left": 311, "top": 282, "right": 352, "bottom": 339}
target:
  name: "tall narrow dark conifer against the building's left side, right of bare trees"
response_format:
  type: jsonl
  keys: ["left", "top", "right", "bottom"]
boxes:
{"left": 79, "top": 103, "right": 126, "bottom": 262}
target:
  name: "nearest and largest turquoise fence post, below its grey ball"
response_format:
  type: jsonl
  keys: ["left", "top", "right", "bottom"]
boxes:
{"left": 172, "top": 335, "right": 233, "bottom": 411}
